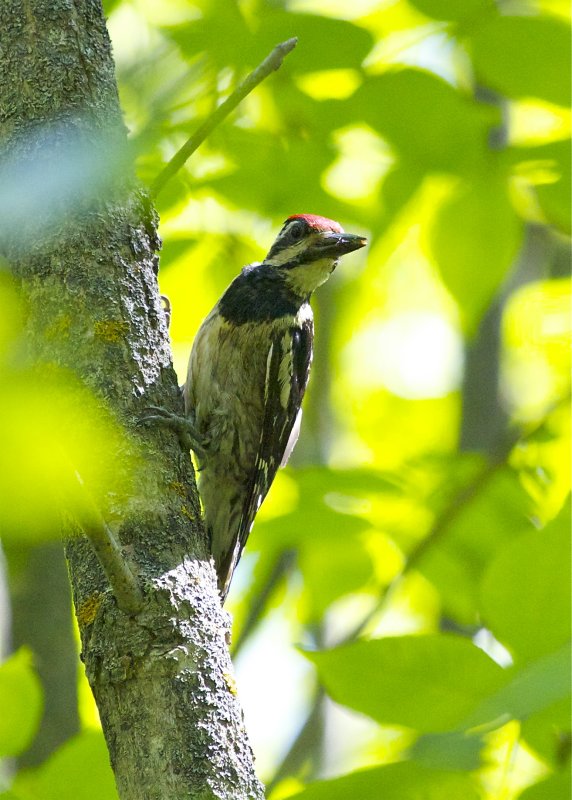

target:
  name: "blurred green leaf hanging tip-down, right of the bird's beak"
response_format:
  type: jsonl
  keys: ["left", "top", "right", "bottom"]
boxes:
{"left": 429, "top": 173, "right": 523, "bottom": 332}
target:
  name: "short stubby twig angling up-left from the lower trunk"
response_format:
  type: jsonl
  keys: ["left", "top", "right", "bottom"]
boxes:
{"left": 72, "top": 473, "right": 143, "bottom": 614}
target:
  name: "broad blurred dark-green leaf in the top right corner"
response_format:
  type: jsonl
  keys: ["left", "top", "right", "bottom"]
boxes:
{"left": 472, "top": 16, "right": 571, "bottom": 106}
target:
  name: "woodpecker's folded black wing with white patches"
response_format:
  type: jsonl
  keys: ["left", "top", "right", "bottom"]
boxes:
{"left": 217, "top": 319, "right": 314, "bottom": 598}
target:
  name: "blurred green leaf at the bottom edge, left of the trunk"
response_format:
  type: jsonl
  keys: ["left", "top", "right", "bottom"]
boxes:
{"left": 15, "top": 731, "right": 118, "bottom": 800}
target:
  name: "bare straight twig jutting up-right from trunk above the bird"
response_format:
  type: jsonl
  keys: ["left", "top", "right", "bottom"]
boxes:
{"left": 150, "top": 37, "right": 298, "bottom": 198}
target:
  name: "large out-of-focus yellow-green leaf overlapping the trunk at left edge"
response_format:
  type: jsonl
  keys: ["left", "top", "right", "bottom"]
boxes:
{"left": 0, "top": 366, "right": 134, "bottom": 539}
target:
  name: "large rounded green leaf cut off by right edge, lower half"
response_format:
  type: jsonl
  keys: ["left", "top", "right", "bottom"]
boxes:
{"left": 481, "top": 507, "right": 571, "bottom": 661}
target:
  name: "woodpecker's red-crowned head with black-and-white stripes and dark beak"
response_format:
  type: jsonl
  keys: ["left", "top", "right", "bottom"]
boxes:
{"left": 264, "top": 214, "right": 367, "bottom": 297}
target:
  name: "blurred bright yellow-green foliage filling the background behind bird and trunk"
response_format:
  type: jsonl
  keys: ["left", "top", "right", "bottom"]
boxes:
{"left": 0, "top": 0, "right": 571, "bottom": 800}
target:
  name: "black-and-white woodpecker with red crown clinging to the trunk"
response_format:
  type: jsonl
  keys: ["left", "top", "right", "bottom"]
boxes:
{"left": 153, "top": 214, "right": 366, "bottom": 602}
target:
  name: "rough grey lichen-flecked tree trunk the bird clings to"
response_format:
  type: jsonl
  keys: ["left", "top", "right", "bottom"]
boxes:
{"left": 0, "top": 0, "right": 263, "bottom": 800}
